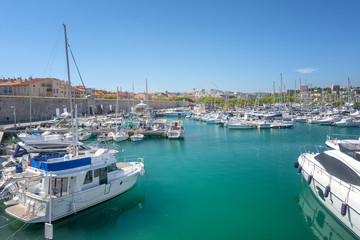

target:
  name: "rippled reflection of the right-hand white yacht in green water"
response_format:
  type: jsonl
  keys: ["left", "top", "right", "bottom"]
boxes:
{"left": 299, "top": 183, "right": 357, "bottom": 240}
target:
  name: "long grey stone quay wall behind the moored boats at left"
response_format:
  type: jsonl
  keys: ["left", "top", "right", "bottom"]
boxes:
{"left": 0, "top": 96, "right": 189, "bottom": 123}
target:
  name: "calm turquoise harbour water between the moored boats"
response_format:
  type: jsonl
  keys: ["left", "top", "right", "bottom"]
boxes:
{"left": 0, "top": 120, "right": 360, "bottom": 239}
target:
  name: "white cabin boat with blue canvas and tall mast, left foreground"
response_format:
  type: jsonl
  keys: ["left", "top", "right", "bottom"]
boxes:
{"left": 5, "top": 25, "right": 145, "bottom": 223}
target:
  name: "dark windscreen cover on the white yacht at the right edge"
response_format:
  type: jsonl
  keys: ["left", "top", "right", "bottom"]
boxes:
{"left": 315, "top": 152, "right": 360, "bottom": 186}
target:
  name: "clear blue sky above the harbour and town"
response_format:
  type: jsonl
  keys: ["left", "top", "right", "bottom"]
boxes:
{"left": 0, "top": 0, "right": 360, "bottom": 92}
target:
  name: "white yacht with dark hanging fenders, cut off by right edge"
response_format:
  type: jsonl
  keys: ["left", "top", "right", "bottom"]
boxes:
{"left": 294, "top": 148, "right": 360, "bottom": 238}
